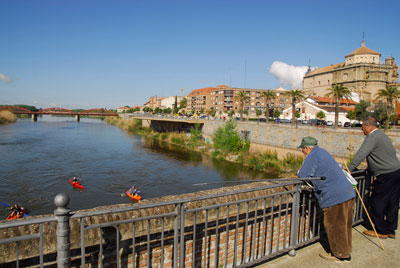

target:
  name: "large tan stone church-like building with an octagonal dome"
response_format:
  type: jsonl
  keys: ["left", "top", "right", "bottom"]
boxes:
{"left": 303, "top": 40, "right": 399, "bottom": 101}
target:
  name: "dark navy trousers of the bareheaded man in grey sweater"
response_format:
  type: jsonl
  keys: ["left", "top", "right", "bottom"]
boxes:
{"left": 369, "top": 169, "right": 400, "bottom": 234}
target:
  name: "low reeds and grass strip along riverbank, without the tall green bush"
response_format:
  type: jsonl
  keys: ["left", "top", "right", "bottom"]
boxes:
{"left": 105, "top": 117, "right": 304, "bottom": 176}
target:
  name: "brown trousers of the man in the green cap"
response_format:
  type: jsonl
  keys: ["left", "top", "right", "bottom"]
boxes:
{"left": 323, "top": 198, "right": 354, "bottom": 258}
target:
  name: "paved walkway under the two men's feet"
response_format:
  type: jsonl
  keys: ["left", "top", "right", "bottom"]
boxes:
{"left": 257, "top": 215, "right": 400, "bottom": 268}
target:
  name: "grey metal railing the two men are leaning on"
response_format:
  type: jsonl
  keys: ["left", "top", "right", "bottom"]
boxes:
{"left": 0, "top": 171, "right": 370, "bottom": 267}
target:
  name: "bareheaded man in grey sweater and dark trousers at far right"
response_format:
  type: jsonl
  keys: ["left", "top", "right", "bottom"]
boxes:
{"left": 349, "top": 118, "right": 400, "bottom": 238}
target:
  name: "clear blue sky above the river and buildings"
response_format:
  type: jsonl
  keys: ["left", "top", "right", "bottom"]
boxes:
{"left": 0, "top": 0, "right": 400, "bottom": 108}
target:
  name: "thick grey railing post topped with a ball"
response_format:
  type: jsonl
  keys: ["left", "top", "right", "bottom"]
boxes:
{"left": 54, "top": 193, "right": 71, "bottom": 268}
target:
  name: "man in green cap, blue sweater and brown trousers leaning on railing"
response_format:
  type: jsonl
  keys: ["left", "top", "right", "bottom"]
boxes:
{"left": 298, "top": 137, "right": 355, "bottom": 262}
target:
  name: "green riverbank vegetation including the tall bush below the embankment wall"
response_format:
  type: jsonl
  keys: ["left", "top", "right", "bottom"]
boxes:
{"left": 105, "top": 117, "right": 303, "bottom": 177}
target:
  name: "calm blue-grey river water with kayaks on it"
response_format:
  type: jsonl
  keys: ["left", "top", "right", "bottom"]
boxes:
{"left": 0, "top": 116, "right": 276, "bottom": 218}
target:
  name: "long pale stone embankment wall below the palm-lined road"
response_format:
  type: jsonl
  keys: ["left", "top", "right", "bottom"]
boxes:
{"left": 203, "top": 121, "right": 400, "bottom": 158}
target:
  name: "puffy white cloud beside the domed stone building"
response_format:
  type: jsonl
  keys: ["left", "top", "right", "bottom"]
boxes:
{"left": 269, "top": 61, "right": 308, "bottom": 88}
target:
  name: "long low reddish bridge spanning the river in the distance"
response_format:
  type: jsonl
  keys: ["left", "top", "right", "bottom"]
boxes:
{"left": 0, "top": 106, "right": 118, "bottom": 122}
